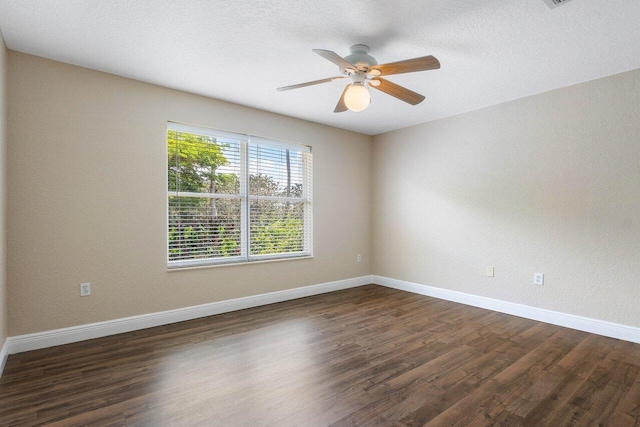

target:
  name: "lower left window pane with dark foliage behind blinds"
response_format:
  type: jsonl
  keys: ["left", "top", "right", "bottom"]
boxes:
{"left": 169, "top": 196, "right": 241, "bottom": 261}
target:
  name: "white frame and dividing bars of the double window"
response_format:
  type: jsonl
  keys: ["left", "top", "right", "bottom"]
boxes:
{"left": 165, "top": 122, "right": 313, "bottom": 269}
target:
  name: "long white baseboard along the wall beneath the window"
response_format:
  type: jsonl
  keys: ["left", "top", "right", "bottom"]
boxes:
{"left": 7, "top": 276, "right": 372, "bottom": 354}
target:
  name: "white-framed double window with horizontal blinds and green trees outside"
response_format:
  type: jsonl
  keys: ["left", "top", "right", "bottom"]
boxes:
{"left": 167, "top": 123, "right": 312, "bottom": 268}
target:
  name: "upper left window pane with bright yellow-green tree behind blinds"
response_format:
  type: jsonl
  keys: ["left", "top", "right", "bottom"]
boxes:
{"left": 167, "top": 130, "right": 240, "bottom": 194}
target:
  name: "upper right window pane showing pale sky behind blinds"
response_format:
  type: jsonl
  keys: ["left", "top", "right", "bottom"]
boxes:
{"left": 249, "top": 144, "right": 304, "bottom": 197}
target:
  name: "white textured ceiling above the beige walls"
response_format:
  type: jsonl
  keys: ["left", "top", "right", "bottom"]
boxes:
{"left": 0, "top": 0, "right": 640, "bottom": 135}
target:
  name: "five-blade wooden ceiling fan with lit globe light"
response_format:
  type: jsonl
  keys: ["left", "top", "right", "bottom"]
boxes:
{"left": 278, "top": 44, "right": 440, "bottom": 113}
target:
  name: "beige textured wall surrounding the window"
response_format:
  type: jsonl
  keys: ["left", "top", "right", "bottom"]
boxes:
{"left": 8, "top": 52, "right": 372, "bottom": 336}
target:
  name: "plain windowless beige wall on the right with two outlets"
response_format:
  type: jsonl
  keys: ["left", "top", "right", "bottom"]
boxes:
{"left": 373, "top": 70, "right": 640, "bottom": 327}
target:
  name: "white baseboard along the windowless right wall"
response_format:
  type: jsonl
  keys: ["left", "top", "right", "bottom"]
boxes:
{"left": 372, "top": 276, "right": 640, "bottom": 343}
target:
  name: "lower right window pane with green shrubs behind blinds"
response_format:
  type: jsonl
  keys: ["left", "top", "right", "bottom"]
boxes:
{"left": 250, "top": 200, "right": 305, "bottom": 255}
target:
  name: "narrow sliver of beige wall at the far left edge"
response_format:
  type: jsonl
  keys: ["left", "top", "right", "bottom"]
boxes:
{"left": 0, "top": 32, "right": 8, "bottom": 348}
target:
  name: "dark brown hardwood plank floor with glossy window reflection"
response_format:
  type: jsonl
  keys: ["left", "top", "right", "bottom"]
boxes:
{"left": 0, "top": 285, "right": 640, "bottom": 427}
